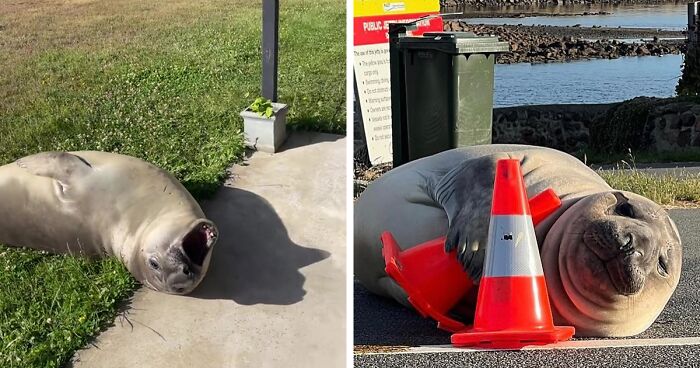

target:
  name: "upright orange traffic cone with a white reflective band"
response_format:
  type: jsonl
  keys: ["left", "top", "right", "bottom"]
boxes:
{"left": 452, "top": 160, "right": 574, "bottom": 348}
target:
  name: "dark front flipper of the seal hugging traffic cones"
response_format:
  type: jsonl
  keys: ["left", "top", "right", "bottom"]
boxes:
{"left": 431, "top": 153, "right": 509, "bottom": 282}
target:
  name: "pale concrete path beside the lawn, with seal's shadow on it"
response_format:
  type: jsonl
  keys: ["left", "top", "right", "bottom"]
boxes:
{"left": 73, "top": 133, "right": 347, "bottom": 368}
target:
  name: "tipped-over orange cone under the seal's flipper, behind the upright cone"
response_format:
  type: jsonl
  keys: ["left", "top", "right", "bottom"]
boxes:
{"left": 381, "top": 189, "right": 561, "bottom": 332}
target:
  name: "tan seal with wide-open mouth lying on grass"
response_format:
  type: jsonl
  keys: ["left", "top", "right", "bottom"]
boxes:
{"left": 0, "top": 151, "right": 218, "bottom": 294}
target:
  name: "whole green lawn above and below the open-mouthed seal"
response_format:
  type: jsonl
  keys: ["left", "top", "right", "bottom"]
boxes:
{"left": 0, "top": 0, "right": 346, "bottom": 368}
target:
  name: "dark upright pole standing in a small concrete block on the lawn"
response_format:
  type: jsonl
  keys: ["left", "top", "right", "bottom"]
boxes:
{"left": 262, "top": 0, "right": 280, "bottom": 101}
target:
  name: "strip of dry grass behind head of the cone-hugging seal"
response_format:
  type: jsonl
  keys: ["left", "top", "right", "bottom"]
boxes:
{"left": 598, "top": 169, "right": 700, "bottom": 207}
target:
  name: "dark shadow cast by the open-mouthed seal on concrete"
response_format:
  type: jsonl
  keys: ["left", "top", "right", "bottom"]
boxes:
{"left": 190, "top": 187, "right": 330, "bottom": 305}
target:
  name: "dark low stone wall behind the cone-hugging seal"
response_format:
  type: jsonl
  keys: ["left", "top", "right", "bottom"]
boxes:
{"left": 493, "top": 97, "right": 700, "bottom": 154}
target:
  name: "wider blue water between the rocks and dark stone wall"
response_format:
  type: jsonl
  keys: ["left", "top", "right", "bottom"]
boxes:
{"left": 494, "top": 55, "right": 682, "bottom": 107}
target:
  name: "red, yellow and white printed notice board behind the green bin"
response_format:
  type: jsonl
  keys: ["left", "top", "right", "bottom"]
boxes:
{"left": 353, "top": 0, "right": 442, "bottom": 165}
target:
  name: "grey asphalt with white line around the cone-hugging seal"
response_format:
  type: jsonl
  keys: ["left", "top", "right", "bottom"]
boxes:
{"left": 354, "top": 209, "right": 700, "bottom": 368}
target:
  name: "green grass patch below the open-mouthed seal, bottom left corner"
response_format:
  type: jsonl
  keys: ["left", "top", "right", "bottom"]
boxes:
{"left": 0, "top": 250, "right": 135, "bottom": 367}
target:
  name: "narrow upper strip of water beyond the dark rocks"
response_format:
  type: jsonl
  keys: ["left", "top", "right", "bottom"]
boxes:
{"left": 456, "top": 2, "right": 688, "bottom": 31}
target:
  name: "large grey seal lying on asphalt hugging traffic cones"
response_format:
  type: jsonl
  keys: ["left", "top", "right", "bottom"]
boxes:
{"left": 354, "top": 145, "right": 681, "bottom": 336}
